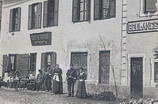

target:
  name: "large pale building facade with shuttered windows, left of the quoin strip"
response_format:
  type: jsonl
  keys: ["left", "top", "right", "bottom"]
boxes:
{"left": 1, "top": 0, "right": 122, "bottom": 96}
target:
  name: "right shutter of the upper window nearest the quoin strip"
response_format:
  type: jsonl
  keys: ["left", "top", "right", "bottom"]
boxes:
{"left": 109, "top": 0, "right": 116, "bottom": 17}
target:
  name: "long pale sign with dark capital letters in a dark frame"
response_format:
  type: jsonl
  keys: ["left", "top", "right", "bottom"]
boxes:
{"left": 127, "top": 18, "right": 158, "bottom": 34}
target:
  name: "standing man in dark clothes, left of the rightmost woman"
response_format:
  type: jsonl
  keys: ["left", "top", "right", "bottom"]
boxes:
{"left": 66, "top": 65, "right": 77, "bottom": 97}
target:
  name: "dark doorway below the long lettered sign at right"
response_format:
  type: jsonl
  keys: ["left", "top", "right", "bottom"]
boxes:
{"left": 130, "top": 57, "right": 143, "bottom": 98}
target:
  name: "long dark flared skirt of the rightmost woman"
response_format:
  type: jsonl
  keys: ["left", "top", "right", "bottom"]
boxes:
{"left": 76, "top": 81, "right": 87, "bottom": 98}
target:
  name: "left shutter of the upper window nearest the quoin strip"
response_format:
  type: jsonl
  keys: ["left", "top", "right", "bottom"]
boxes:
{"left": 94, "top": 0, "right": 101, "bottom": 20}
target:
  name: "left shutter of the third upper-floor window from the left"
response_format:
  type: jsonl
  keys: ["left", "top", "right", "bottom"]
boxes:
{"left": 43, "top": 1, "right": 48, "bottom": 27}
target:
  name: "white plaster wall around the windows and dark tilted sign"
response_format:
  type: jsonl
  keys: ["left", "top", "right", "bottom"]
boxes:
{"left": 1, "top": 0, "right": 121, "bottom": 83}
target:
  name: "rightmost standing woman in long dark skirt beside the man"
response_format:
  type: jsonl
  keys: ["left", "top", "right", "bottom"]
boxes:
{"left": 76, "top": 67, "right": 87, "bottom": 98}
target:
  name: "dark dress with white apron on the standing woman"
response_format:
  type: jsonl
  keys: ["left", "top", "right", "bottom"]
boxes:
{"left": 53, "top": 68, "right": 63, "bottom": 94}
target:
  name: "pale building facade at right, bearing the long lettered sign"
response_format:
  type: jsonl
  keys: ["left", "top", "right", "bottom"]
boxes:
{"left": 126, "top": 0, "right": 158, "bottom": 96}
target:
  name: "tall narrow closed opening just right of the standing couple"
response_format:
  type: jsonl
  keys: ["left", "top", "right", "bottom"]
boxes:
{"left": 99, "top": 51, "right": 110, "bottom": 84}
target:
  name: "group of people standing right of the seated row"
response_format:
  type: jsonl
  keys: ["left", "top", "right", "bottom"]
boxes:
{"left": 36, "top": 64, "right": 87, "bottom": 98}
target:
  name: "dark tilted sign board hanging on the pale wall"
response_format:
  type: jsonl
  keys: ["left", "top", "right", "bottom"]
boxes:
{"left": 30, "top": 32, "right": 52, "bottom": 46}
